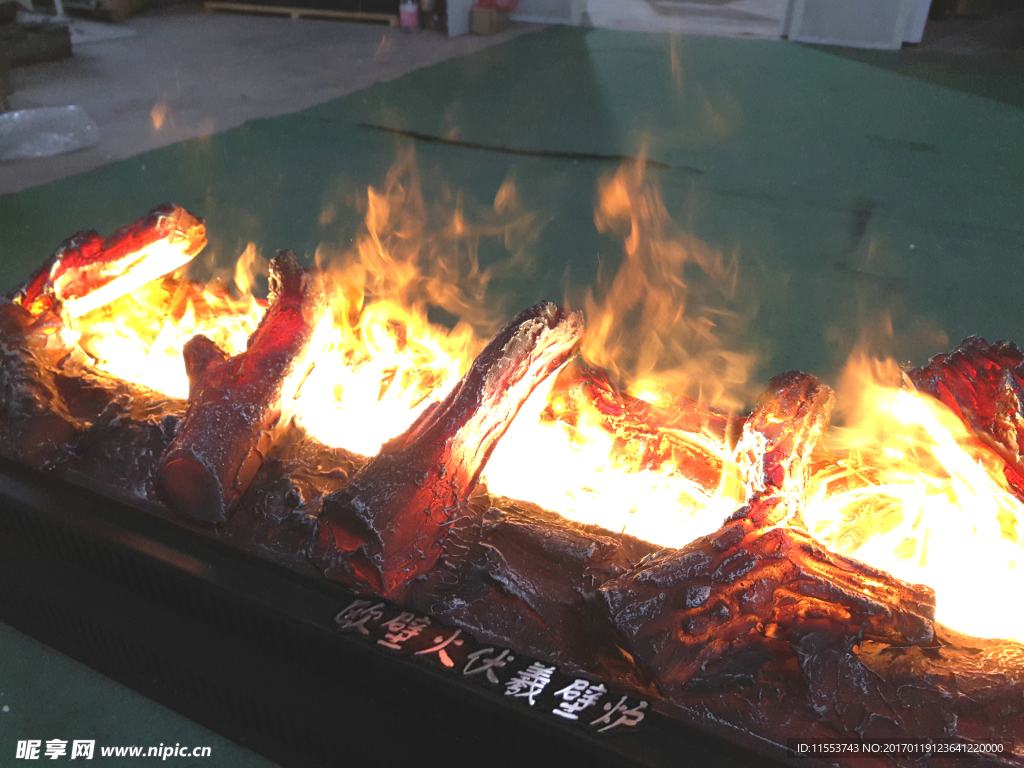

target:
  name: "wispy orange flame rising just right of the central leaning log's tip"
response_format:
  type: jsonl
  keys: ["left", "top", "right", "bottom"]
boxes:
{"left": 583, "top": 162, "right": 755, "bottom": 411}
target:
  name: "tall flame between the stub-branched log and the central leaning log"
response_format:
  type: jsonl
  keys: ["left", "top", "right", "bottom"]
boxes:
{"left": 288, "top": 156, "right": 516, "bottom": 456}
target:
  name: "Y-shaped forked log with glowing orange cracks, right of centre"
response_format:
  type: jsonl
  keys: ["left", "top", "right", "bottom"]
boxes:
{"left": 600, "top": 374, "right": 934, "bottom": 695}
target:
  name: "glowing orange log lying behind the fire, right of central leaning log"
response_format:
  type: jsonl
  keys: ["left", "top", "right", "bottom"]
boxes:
{"left": 544, "top": 360, "right": 737, "bottom": 492}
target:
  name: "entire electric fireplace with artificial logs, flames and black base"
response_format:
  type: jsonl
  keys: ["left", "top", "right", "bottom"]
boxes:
{"left": 0, "top": 171, "right": 1024, "bottom": 765}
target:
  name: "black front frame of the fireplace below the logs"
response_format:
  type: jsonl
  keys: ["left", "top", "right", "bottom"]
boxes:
{"left": 0, "top": 458, "right": 790, "bottom": 768}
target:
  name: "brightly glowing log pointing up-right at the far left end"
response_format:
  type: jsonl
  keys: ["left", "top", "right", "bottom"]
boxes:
{"left": 13, "top": 204, "right": 206, "bottom": 318}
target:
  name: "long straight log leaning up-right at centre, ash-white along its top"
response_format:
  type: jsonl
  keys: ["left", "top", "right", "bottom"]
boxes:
{"left": 317, "top": 302, "right": 583, "bottom": 602}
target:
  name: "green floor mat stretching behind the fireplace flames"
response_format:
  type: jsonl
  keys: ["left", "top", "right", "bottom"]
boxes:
{"left": 0, "top": 28, "right": 1024, "bottom": 387}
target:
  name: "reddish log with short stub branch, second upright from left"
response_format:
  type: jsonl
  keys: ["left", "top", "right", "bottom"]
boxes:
{"left": 159, "top": 251, "right": 326, "bottom": 522}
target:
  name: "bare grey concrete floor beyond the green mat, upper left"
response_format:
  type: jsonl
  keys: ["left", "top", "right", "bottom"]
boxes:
{"left": 0, "top": 6, "right": 542, "bottom": 195}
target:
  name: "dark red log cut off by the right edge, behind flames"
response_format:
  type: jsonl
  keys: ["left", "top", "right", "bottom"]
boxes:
{"left": 906, "top": 336, "right": 1024, "bottom": 498}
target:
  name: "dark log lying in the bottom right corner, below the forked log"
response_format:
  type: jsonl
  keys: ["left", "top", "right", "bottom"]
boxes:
{"left": 662, "top": 626, "right": 1024, "bottom": 768}
